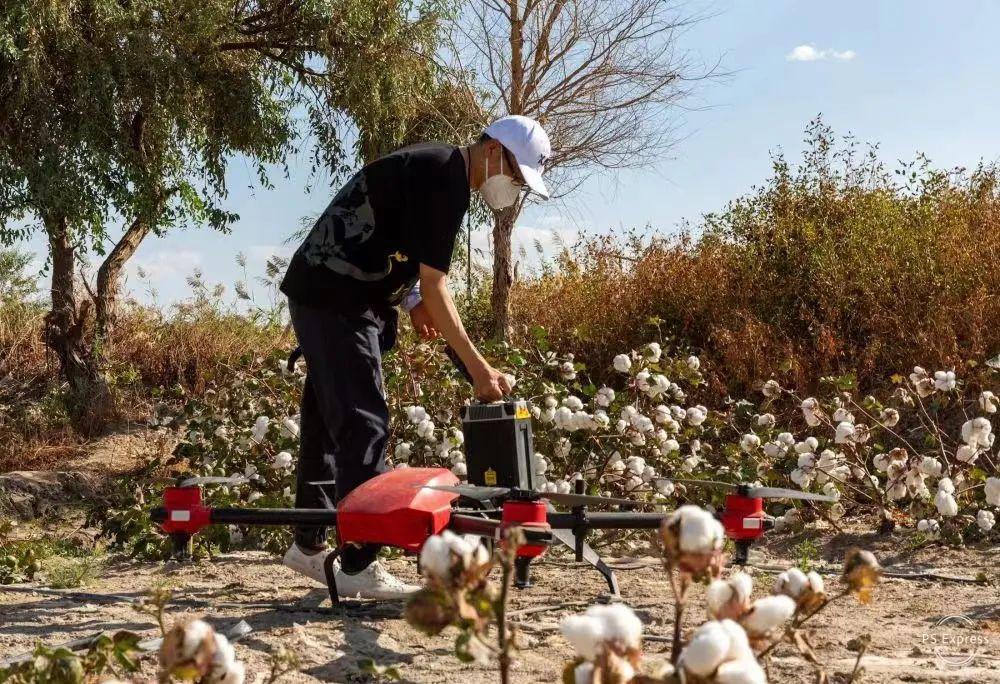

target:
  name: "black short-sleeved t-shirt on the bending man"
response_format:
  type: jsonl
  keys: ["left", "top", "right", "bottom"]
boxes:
{"left": 281, "top": 143, "right": 469, "bottom": 311}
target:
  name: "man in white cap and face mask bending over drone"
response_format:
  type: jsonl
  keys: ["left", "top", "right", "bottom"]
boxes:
{"left": 281, "top": 116, "right": 551, "bottom": 599}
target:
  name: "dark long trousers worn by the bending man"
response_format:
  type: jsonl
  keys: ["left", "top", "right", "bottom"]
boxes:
{"left": 289, "top": 301, "right": 396, "bottom": 573}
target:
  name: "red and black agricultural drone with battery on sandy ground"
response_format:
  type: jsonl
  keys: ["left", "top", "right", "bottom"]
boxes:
{"left": 151, "top": 400, "right": 835, "bottom": 606}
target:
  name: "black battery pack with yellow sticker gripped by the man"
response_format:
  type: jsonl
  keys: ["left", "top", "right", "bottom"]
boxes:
{"left": 462, "top": 401, "right": 535, "bottom": 490}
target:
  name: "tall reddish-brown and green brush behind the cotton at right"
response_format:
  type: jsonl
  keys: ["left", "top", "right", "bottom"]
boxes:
{"left": 514, "top": 128, "right": 1000, "bottom": 394}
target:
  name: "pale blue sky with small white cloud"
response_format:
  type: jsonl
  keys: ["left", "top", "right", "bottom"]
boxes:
{"left": 15, "top": 0, "right": 1000, "bottom": 306}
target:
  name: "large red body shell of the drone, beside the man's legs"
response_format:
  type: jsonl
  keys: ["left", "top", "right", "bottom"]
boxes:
{"left": 337, "top": 468, "right": 458, "bottom": 553}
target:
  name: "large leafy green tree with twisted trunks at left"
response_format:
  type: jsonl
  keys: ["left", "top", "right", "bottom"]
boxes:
{"left": 0, "top": 0, "right": 466, "bottom": 422}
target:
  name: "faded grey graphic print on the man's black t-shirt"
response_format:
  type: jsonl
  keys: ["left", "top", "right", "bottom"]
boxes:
{"left": 303, "top": 171, "right": 392, "bottom": 281}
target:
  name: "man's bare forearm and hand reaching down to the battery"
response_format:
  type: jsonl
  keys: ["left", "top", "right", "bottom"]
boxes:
{"left": 420, "top": 264, "right": 511, "bottom": 401}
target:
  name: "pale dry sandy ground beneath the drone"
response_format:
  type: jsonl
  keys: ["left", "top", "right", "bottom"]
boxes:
{"left": 0, "top": 535, "right": 1000, "bottom": 684}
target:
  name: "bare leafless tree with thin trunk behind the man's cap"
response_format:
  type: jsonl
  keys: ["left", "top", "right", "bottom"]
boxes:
{"left": 451, "top": 0, "right": 710, "bottom": 339}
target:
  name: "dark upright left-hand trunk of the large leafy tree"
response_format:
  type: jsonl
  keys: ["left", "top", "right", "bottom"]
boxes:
{"left": 45, "top": 216, "right": 111, "bottom": 433}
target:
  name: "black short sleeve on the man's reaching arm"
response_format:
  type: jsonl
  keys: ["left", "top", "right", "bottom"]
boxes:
{"left": 410, "top": 154, "right": 468, "bottom": 273}
